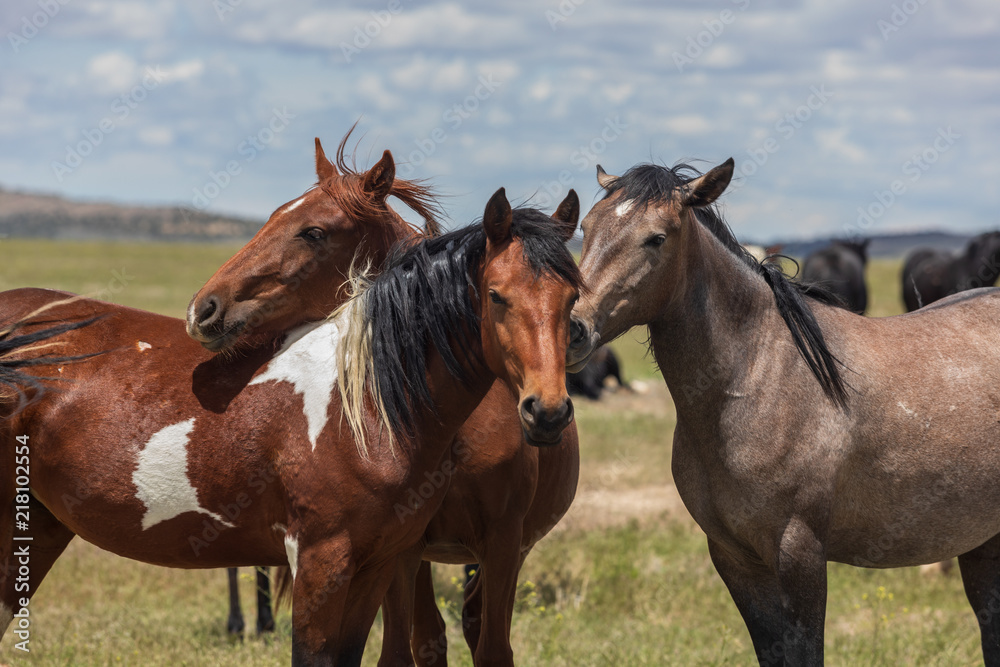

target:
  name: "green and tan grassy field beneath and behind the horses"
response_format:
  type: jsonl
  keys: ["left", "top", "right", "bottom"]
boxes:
{"left": 0, "top": 241, "right": 981, "bottom": 667}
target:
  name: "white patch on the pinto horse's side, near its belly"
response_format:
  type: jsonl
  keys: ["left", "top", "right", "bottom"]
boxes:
{"left": 132, "top": 417, "right": 233, "bottom": 530}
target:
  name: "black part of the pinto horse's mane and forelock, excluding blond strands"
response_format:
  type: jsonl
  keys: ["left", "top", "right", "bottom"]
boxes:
{"left": 365, "top": 208, "right": 582, "bottom": 433}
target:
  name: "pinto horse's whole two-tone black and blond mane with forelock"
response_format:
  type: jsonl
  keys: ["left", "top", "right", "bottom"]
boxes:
{"left": 335, "top": 208, "right": 581, "bottom": 456}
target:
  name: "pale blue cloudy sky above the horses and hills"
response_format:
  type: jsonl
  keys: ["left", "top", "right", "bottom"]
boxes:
{"left": 0, "top": 0, "right": 1000, "bottom": 241}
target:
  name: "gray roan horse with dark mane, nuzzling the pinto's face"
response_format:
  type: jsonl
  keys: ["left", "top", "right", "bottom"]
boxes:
{"left": 569, "top": 160, "right": 1000, "bottom": 665}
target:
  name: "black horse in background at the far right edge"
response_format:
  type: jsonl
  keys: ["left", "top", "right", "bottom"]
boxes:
{"left": 903, "top": 231, "right": 1000, "bottom": 312}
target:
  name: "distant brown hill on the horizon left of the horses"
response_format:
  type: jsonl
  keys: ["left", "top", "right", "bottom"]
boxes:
{"left": 0, "top": 188, "right": 264, "bottom": 241}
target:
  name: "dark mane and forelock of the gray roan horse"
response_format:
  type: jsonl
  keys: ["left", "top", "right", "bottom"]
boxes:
{"left": 605, "top": 163, "right": 847, "bottom": 408}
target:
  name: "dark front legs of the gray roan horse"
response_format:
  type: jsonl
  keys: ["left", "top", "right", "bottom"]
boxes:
{"left": 708, "top": 538, "right": 826, "bottom": 665}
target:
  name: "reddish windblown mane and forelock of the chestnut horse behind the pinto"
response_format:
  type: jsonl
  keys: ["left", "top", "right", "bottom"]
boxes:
{"left": 318, "top": 127, "right": 442, "bottom": 236}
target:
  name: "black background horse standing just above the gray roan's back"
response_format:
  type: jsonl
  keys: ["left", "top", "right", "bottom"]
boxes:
{"left": 801, "top": 239, "right": 869, "bottom": 315}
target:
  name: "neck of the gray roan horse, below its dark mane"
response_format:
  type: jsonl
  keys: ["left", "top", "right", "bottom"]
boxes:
{"left": 649, "top": 221, "right": 782, "bottom": 420}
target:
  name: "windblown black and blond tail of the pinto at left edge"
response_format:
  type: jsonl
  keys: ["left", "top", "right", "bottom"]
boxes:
{"left": 0, "top": 315, "right": 104, "bottom": 414}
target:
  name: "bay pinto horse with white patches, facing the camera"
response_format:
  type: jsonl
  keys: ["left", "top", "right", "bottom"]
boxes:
{"left": 0, "top": 183, "right": 578, "bottom": 665}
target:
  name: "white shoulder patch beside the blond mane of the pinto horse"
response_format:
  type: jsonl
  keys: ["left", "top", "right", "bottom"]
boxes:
{"left": 250, "top": 320, "right": 340, "bottom": 450}
